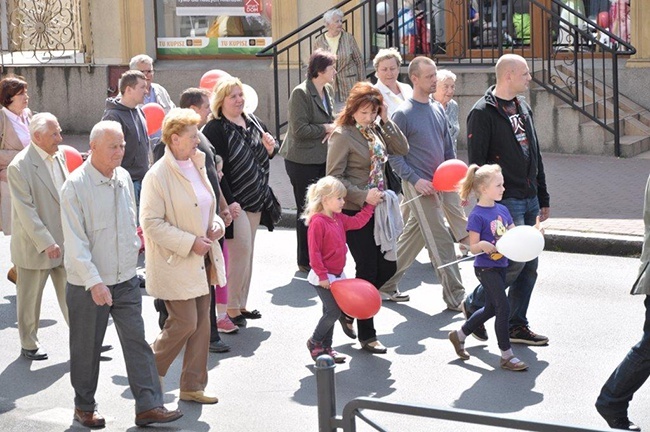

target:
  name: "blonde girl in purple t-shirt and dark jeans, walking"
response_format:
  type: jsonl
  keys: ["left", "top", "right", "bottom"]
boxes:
{"left": 449, "top": 164, "right": 528, "bottom": 371}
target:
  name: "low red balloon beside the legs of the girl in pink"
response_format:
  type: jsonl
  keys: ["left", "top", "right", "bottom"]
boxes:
{"left": 330, "top": 279, "right": 381, "bottom": 319}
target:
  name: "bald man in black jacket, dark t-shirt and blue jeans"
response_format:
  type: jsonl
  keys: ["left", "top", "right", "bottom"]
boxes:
{"left": 463, "top": 54, "right": 550, "bottom": 345}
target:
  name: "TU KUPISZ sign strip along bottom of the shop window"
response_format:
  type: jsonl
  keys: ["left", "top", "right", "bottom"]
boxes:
{"left": 157, "top": 36, "right": 273, "bottom": 55}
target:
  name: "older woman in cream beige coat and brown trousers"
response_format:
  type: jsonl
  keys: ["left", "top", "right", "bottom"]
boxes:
{"left": 140, "top": 108, "right": 226, "bottom": 403}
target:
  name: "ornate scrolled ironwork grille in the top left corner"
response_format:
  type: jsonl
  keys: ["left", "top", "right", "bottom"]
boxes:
{"left": 2, "top": 0, "right": 87, "bottom": 65}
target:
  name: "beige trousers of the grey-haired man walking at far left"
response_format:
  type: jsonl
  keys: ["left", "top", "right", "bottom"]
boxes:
{"left": 16, "top": 265, "right": 69, "bottom": 350}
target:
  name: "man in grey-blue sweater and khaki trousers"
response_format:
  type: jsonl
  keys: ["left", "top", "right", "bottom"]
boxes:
{"left": 381, "top": 57, "right": 465, "bottom": 311}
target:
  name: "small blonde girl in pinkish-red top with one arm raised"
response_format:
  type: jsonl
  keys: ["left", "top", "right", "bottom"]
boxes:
{"left": 301, "top": 176, "right": 381, "bottom": 363}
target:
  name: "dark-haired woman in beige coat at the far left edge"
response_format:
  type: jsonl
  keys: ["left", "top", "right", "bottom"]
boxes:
{"left": 0, "top": 75, "right": 32, "bottom": 283}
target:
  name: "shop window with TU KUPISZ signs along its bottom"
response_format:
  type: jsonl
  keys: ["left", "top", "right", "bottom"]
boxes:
{"left": 156, "top": 0, "right": 272, "bottom": 56}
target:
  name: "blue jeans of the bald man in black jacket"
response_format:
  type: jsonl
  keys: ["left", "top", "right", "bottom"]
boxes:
{"left": 465, "top": 197, "right": 539, "bottom": 329}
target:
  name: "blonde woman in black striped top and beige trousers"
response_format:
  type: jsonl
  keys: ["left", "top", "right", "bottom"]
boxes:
{"left": 202, "top": 77, "right": 279, "bottom": 327}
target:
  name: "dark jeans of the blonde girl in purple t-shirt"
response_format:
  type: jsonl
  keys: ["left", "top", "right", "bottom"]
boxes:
{"left": 461, "top": 267, "right": 510, "bottom": 351}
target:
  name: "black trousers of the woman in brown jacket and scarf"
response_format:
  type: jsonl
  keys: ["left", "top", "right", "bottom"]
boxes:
{"left": 343, "top": 210, "right": 397, "bottom": 343}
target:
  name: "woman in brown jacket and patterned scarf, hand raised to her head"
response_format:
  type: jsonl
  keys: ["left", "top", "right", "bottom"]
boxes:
{"left": 327, "top": 82, "right": 409, "bottom": 354}
